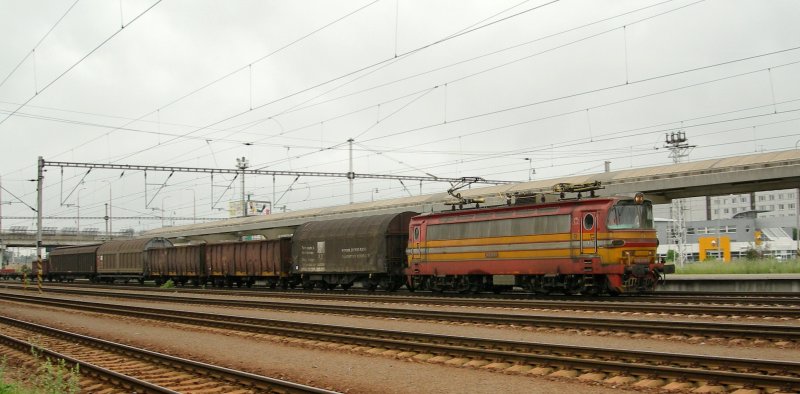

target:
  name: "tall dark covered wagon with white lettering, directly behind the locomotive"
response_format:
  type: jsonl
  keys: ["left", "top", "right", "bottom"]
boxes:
{"left": 292, "top": 212, "right": 417, "bottom": 290}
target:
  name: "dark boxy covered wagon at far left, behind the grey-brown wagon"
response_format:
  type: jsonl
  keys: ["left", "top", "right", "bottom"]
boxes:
{"left": 48, "top": 244, "right": 100, "bottom": 282}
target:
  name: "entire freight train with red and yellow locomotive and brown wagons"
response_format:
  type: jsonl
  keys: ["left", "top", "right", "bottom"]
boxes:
{"left": 34, "top": 186, "right": 674, "bottom": 295}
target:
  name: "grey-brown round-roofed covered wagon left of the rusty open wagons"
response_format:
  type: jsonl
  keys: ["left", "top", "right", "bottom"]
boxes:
{"left": 97, "top": 238, "right": 172, "bottom": 283}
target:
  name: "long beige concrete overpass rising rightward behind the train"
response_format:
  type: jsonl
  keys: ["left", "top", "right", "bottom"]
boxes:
{"left": 138, "top": 150, "right": 800, "bottom": 242}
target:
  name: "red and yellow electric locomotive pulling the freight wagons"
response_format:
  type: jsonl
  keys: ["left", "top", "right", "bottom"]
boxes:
{"left": 407, "top": 185, "right": 674, "bottom": 294}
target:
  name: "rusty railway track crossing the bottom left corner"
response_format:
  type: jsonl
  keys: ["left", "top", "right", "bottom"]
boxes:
{"left": 0, "top": 316, "right": 332, "bottom": 393}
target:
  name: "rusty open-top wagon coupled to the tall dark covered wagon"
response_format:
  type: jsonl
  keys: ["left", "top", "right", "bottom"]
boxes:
{"left": 205, "top": 238, "right": 294, "bottom": 288}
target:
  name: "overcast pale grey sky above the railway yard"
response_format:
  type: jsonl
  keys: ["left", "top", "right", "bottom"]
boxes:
{"left": 0, "top": 0, "right": 800, "bottom": 231}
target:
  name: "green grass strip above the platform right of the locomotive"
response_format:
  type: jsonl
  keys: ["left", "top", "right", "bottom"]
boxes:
{"left": 675, "top": 259, "right": 800, "bottom": 274}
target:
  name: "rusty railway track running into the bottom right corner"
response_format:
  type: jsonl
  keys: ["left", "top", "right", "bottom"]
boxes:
{"left": 2, "top": 294, "right": 800, "bottom": 392}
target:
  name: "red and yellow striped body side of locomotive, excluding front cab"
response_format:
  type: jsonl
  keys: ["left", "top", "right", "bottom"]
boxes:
{"left": 408, "top": 207, "right": 578, "bottom": 275}
